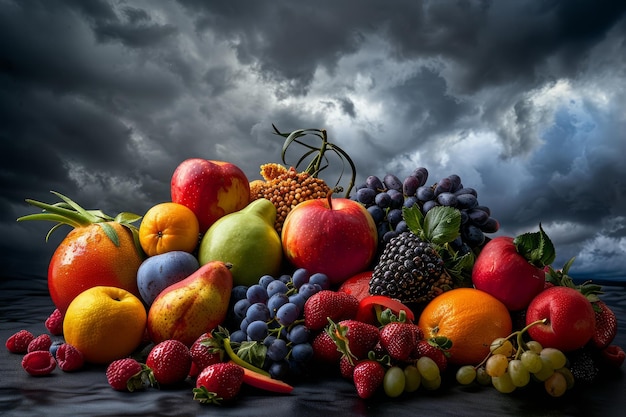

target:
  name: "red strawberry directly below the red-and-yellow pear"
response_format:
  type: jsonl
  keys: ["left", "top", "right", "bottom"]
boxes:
{"left": 146, "top": 339, "right": 191, "bottom": 385}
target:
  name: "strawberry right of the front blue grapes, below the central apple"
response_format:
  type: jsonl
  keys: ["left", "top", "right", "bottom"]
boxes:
{"left": 304, "top": 290, "right": 359, "bottom": 330}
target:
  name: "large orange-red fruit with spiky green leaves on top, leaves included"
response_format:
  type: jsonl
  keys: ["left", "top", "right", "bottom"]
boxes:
{"left": 17, "top": 191, "right": 145, "bottom": 315}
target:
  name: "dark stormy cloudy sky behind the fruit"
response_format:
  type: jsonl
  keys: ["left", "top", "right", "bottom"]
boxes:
{"left": 0, "top": 0, "right": 626, "bottom": 278}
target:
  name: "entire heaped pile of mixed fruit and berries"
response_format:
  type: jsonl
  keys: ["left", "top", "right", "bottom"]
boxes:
{"left": 6, "top": 129, "right": 626, "bottom": 403}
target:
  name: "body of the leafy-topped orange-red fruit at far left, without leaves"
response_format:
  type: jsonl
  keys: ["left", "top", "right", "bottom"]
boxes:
{"left": 48, "top": 222, "right": 143, "bottom": 313}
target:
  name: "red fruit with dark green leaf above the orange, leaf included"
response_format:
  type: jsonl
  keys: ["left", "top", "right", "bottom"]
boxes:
{"left": 472, "top": 224, "right": 556, "bottom": 312}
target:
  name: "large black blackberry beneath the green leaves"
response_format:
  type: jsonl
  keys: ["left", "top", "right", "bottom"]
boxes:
{"left": 369, "top": 232, "right": 454, "bottom": 303}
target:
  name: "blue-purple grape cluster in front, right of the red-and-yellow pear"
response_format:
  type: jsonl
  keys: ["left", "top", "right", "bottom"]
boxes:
{"left": 228, "top": 268, "right": 330, "bottom": 379}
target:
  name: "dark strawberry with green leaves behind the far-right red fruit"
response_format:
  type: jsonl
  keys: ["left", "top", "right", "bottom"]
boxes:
{"left": 546, "top": 258, "right": 617, "bottom": 349}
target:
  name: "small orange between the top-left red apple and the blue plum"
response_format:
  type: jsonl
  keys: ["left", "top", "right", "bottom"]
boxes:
{"left": 139, "top": 202, "right": 200, "bottom": 256}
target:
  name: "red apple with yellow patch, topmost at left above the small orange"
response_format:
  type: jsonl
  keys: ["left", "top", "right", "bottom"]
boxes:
{"left": 171, "top": 158, "right": 250, "bottom": 233}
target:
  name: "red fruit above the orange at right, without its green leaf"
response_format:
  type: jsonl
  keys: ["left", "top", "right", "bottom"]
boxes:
{"left": 472, "top": 236, "right": 546, "bottom": 311}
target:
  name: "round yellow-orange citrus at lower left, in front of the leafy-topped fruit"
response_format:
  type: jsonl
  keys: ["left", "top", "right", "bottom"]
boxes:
{"left": 63, "top": 286, "right": 147, "bottom": 364}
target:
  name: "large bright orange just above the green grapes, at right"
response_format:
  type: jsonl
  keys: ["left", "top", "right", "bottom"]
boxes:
{"left": 418, "top": 288, "right": 513, "bottom": 365}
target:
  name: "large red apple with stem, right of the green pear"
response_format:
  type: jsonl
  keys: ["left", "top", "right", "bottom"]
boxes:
{"left": 281, "top": 193, "right": 378, "bottom": 285}
